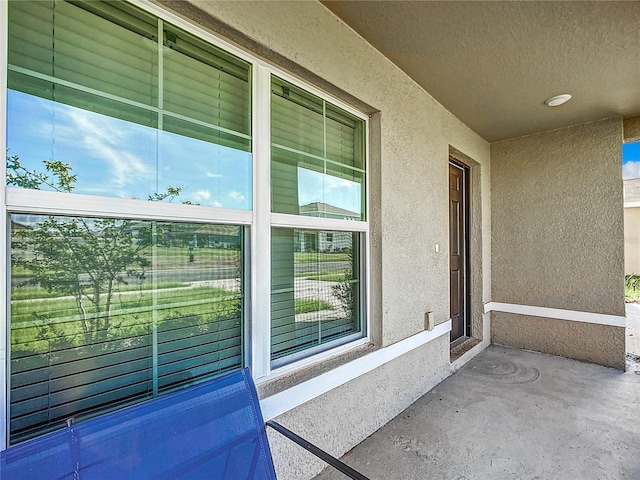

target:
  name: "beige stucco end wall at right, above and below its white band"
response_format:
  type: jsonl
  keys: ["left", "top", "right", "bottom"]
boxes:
{"left": 491, "top": 119, "right": 625, "bottom": 368}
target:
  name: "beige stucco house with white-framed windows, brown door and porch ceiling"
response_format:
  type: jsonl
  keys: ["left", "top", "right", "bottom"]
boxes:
{"left": 0, "top": 0, "right": 640, "bottom": 480}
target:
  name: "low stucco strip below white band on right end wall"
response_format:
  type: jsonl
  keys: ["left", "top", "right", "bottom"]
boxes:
{"left": 491, "top": 312, "right": 626, "bottom": 370}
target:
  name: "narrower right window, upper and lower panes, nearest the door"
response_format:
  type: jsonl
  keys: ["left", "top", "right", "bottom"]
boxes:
{"left": 271, "top": 76, "right": 366, "bottom": 367}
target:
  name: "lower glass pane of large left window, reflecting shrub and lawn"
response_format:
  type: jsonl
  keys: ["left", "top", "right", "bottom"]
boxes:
{"left": 10, "top": 214, "right": 243, "bottom": 443}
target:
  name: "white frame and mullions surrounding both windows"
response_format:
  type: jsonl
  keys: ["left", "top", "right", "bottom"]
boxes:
{"left": 0, "top": 0, "right": 370, "bottom": 450}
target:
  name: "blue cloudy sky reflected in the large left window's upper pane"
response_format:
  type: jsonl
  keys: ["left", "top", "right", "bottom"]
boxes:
{"left": 7, "top": 90, "right": 252, "bottom": 210}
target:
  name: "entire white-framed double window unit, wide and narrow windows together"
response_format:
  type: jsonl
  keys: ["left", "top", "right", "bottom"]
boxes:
{"left": 0, "top": 0, "right": 368, "bottom": 448}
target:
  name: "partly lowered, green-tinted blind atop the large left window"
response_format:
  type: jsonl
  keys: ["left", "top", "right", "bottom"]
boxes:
{"left": 9, "top": 0, "right": 251, "bottom": 151}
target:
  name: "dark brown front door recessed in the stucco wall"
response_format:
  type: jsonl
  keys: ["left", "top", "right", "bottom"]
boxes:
{"left": 449, "top": 163, "right": 470, "bottom": 342}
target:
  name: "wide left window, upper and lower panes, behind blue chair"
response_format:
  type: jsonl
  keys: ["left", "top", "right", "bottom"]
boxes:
{"left": 6, "top": 0, "right": 253, "bottom": 444}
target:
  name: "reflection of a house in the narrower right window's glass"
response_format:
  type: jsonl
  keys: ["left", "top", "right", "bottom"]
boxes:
{"left": 295, "top": 202, "right": 360, "bottom": 252}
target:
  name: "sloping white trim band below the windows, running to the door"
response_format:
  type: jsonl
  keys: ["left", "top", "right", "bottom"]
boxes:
{"left": 260, "top": 320, "right": 451, "bottom": 421}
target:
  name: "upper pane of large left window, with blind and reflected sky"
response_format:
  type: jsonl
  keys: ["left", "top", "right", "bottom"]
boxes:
{"left": 7, "top": 0, "right": 252, "bottom": 210}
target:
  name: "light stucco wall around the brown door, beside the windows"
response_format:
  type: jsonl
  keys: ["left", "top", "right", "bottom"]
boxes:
{"left": 159, "top": 1, "right": 490, "bottom": 480}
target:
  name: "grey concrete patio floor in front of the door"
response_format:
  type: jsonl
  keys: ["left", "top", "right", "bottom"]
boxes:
{"left": 316, "top": 346, "right": 640, "bottom": 480}
